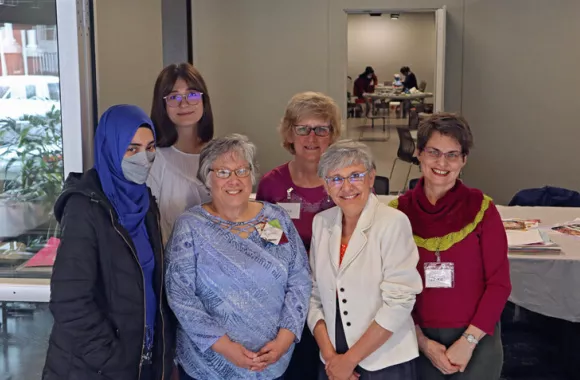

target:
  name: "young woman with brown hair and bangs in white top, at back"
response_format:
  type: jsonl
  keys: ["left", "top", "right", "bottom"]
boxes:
{"left": 147, "top": 63, "right": 214, "bottom": 245}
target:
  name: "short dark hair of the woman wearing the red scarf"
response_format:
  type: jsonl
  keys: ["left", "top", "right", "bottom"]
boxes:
{"left": 417, "top": 112, "right": 473, "bottom": 155}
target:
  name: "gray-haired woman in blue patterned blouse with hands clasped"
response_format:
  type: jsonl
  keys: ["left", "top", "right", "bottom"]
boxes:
{"left": 166, "top": 135, "right": 312, "bottom": 380}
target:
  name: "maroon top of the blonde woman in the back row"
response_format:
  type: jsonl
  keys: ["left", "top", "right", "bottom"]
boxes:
{"left": 256, "top": 163, "right": 334, "bottom": 252}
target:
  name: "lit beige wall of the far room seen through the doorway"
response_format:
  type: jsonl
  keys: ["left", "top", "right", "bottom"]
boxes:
{"left": 348, "top": 12, "right": 436, "bottom": 91}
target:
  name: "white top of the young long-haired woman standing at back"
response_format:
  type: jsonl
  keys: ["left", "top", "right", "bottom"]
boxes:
{"left": 147, "top": 146, "right": 211, "bottom": 245}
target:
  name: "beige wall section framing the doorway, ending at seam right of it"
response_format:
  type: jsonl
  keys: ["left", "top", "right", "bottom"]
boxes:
{"left": 192, "top": 0, "right": 463, "bottom": 173}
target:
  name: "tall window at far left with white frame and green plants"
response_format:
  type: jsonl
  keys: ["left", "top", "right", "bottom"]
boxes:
{"left": 0, "top": 0, "right": 93, "bottom": 379}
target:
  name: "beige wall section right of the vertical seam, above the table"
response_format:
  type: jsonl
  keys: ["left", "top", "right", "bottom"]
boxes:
{"left": 463, "top": 0, "right": 580, "bottom": 204}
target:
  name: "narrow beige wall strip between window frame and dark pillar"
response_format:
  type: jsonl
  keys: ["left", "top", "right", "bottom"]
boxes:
{"left": 94, "top": 0, "right": 163, "bottom": 115}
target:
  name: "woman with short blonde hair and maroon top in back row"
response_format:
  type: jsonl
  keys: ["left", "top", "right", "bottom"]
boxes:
{"left": 256, "top": 92, "right": 341, "bottom": 380}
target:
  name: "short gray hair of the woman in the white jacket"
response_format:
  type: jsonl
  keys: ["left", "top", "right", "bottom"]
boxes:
{"left": 318, "top": 140, "right": 375, "bottom": 178}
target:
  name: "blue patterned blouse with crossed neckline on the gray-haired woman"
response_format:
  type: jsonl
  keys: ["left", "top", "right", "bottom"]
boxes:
{"left": 166, "top": 203, "right": 312, "bottom": 380}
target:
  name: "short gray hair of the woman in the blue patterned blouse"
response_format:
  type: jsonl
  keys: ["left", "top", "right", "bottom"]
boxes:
{"left": 197, "top": 133, "right": 258, "bottom": 189}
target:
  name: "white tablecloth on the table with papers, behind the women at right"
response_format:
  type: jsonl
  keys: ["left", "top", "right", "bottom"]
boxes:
{"left": 379, "top": 195, "right": 580, "bottom": 322}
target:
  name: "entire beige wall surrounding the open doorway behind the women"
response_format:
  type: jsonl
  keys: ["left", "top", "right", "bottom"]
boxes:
{"left": 193, "top": 0, "right": 580, "bottom": 203}
